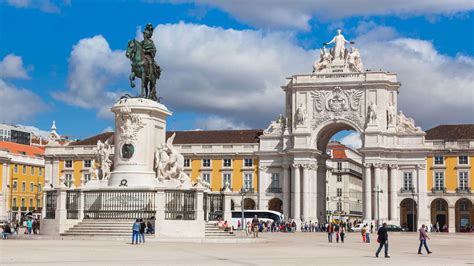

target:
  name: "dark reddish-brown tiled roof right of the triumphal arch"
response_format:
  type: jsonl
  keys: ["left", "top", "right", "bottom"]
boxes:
{"left": 425, "top": 124, "right": 474, "bottom": 140}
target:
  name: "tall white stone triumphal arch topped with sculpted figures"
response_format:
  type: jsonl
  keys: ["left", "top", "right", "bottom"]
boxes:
{"left": 259, "top": 31, "right": 429, "bottom": 227}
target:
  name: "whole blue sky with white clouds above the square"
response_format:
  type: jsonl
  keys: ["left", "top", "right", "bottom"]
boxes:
{"left": 0, "top": 0, "right": 474, "bottom": 145}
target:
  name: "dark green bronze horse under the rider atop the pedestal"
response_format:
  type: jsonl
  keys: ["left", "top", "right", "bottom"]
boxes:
{"left": 125, "top": 40, "right": 161, "bottom": 101}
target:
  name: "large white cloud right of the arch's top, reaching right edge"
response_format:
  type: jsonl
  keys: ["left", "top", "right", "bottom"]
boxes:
{"left": 356, "top": 26, "right": 474, "bottom": 129}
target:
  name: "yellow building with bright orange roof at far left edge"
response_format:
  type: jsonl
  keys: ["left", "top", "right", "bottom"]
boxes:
{"left": 0, "top": 141, "right": 45, "bottom": 220}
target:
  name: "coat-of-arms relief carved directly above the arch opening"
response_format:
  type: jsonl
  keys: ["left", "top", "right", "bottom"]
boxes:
{"left": 311, "top": 87, "right": 364, "bottom": 128}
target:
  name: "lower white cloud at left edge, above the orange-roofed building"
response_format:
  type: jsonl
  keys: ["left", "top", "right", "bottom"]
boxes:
{"left": 0, "top": 79, "right": 47, "bottom": 123}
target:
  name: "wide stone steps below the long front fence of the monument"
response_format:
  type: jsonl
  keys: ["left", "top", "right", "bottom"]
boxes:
{"left": 61, "top": 219, "right": 134, "bottom": 237}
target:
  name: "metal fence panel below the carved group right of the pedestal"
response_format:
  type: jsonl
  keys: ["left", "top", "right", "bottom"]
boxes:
{"left": 165, "top": 190, "right": 196, "bottom": 220}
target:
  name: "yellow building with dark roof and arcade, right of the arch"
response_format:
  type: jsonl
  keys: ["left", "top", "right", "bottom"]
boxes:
{"left": 426, "top": 125, "right": 474, "bottom": 232}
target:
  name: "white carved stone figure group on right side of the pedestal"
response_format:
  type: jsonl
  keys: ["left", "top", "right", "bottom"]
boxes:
{"left": 155, "top": 133, "right": 190, "bottom": 183}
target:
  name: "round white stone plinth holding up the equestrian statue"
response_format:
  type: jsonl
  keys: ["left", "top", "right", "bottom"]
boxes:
{"left": 108, "top": 98, "right": 172, "bottom": 187}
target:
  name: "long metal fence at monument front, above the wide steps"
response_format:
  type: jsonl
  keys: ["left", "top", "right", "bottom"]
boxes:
{"left": 83, "top": 190, "right": 156, "bottom": 219}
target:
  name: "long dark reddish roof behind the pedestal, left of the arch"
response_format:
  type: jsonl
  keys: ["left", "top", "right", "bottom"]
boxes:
{"left": 70, "top": 129, "right": 263, "bottom": 145}
